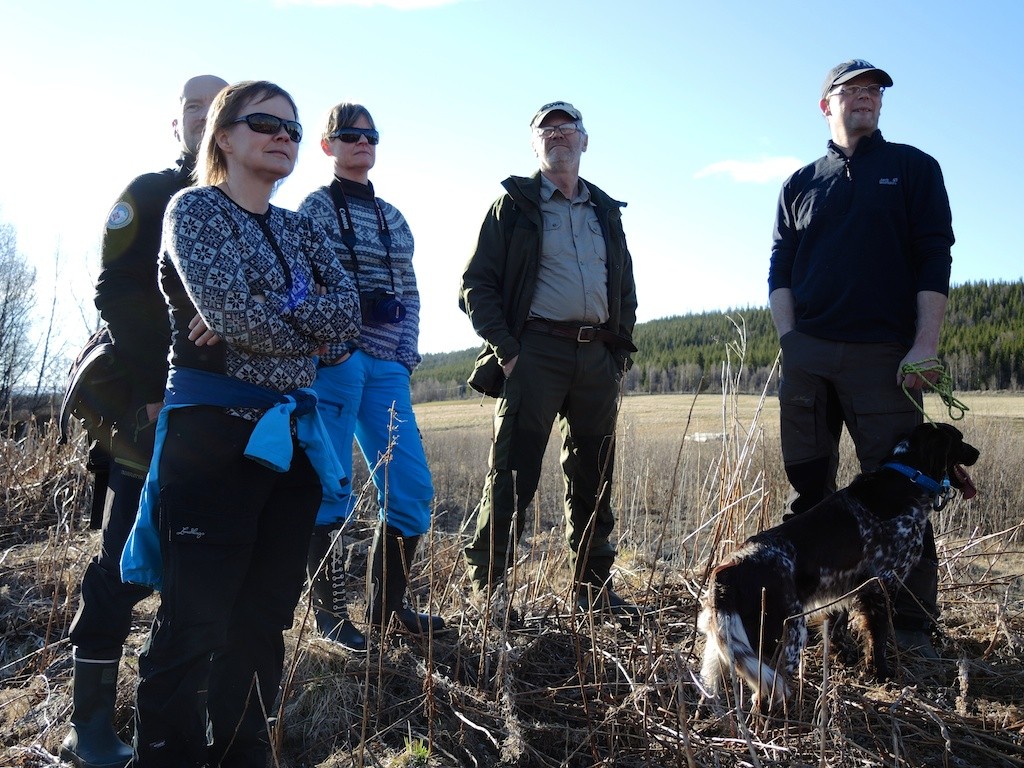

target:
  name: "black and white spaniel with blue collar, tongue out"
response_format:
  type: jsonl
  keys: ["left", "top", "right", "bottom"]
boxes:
{"left": 698, "top": 424, "right": 978, "bottom": 703}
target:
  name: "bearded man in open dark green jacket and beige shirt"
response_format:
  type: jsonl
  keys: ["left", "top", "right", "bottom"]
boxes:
{"left": 460, "top": 101, "right": 637, "bottom": 615}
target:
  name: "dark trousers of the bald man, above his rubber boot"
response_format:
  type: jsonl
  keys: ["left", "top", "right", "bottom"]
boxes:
{"left": 71, "top": 461, "right": 153, "bottom": 662}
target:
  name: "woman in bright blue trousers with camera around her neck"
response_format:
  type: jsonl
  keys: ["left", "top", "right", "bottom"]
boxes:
{"left": 299, "top": 103, "right": 444, "bottom": 651}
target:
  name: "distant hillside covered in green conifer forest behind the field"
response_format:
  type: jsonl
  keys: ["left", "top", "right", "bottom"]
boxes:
{"left": 413, "top": 281, "right": 1024, "bottom": 401}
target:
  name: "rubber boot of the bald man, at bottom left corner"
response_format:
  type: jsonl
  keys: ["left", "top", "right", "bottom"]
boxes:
{"left": 60, "top": 658, "right": 132, "bottom": 768}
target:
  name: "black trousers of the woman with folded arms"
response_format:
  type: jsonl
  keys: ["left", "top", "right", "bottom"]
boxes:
{"left": 133, "top": 408, "right": 321, "bottom": 768}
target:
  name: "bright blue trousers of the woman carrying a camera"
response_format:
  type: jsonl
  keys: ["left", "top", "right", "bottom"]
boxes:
{"left": 313, "top": 349, "right": 434, "bottom": 536}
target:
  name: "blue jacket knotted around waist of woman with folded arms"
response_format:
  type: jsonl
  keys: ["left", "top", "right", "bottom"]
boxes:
{"left": 121, "top": 368, "right": 348, "bottom": 590}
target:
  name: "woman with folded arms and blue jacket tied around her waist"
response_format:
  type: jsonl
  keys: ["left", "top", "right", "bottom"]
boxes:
{"left": 129, "top": 81, "right": 358, "bottom": 768}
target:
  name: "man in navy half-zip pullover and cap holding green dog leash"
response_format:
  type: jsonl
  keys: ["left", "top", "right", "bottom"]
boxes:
{"left": 768, "top": 59, "right": 953, "bottom": 657}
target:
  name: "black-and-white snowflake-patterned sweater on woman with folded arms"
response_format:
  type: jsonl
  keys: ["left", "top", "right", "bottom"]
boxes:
{"left": 160, "top": 186, "right": 359, "bottom": 409}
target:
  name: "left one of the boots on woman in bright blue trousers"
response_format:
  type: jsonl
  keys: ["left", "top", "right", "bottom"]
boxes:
{"left": 306, "top": 525, "right": 367, "bottom": 653}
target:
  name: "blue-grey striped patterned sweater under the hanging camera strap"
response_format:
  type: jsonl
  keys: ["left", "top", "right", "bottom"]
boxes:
{"left": 299, "top": 180, "right": 422, "bottom": 371}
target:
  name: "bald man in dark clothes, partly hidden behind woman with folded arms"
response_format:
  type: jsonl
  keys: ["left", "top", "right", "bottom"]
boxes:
{"left": 60, "top": 75, "right": 227, "bottom": 768}
